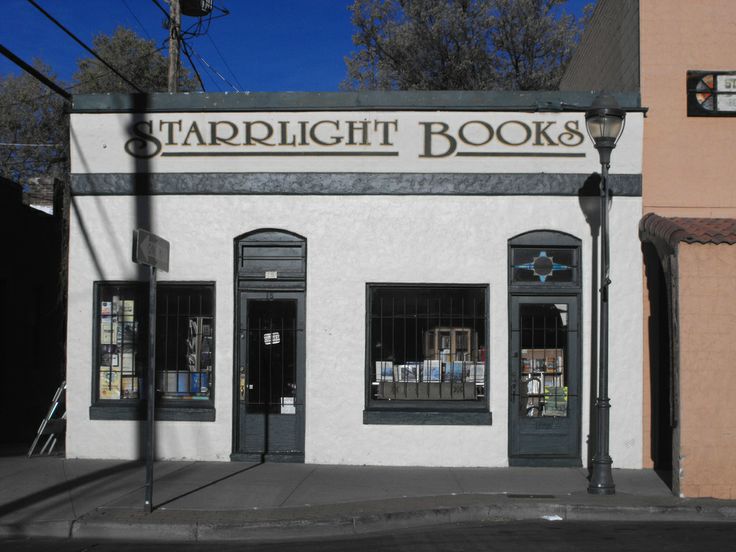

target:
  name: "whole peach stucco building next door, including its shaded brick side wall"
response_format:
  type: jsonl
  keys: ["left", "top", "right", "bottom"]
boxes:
{"left": 561, "top": 0, "right": 736, "bottom": 498}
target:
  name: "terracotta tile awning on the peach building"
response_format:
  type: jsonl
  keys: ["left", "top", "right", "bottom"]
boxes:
{"left": 639, "top": 213, "right": 736, "bottom": 247}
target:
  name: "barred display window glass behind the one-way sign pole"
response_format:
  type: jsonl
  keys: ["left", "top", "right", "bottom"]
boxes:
{"left": 93, "top": 282, "right": 215, "bottom": 420}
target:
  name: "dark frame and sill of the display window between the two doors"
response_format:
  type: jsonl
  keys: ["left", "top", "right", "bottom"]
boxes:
{"left": 363, "top": 282, "right": 492, "bottom": 425}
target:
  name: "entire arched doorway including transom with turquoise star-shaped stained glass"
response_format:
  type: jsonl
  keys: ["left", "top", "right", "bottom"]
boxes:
{"left": 508, "top": 230, "right": 582, "bottom": 466}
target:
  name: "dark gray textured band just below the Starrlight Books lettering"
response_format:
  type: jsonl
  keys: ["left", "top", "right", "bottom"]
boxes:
{"left": 72, "top": 173, "right": 641, "bottom": 197}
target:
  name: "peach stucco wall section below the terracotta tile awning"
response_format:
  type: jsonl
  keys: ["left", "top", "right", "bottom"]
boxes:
{"left": 679, "top": 244, "right": 736, "bottom": 499}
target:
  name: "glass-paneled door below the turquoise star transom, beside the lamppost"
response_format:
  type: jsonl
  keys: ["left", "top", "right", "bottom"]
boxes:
{"left": 509, "top": 295, "right": 581, "bottom": 466}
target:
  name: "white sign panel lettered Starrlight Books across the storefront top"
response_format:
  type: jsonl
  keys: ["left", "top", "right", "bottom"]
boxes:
{"left": 71, "top": 111, "right": 641, "bottom": 174}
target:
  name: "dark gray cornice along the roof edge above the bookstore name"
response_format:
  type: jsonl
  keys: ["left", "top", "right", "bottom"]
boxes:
{"left": 72, "top": 90, "right": 646, "bottom": 113}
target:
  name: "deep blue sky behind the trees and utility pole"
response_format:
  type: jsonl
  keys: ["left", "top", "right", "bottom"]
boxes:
{"left": 0, "top": 0, "right": 592, "bottom": 92}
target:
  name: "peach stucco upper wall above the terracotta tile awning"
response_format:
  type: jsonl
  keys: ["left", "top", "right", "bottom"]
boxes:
{"left": 640, "top": 0, "right": 736, "bottom": 217}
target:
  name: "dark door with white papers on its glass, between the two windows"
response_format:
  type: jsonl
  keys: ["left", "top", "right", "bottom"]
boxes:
{"left": 238, "top": 291, "right": 304, "bottom": 462}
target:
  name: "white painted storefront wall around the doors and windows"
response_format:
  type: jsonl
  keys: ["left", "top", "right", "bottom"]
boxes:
{"left": 67, "top": 192, "right": 642, "bottom": 468}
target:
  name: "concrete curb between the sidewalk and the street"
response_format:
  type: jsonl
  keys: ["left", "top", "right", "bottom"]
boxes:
{"left": 56, "top": 501, "right": 736, "bottom": 542}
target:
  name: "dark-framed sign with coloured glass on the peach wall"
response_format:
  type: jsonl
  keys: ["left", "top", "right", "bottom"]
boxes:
{"left": 687, "top": 71, "right": 736, "bottom": 117}
